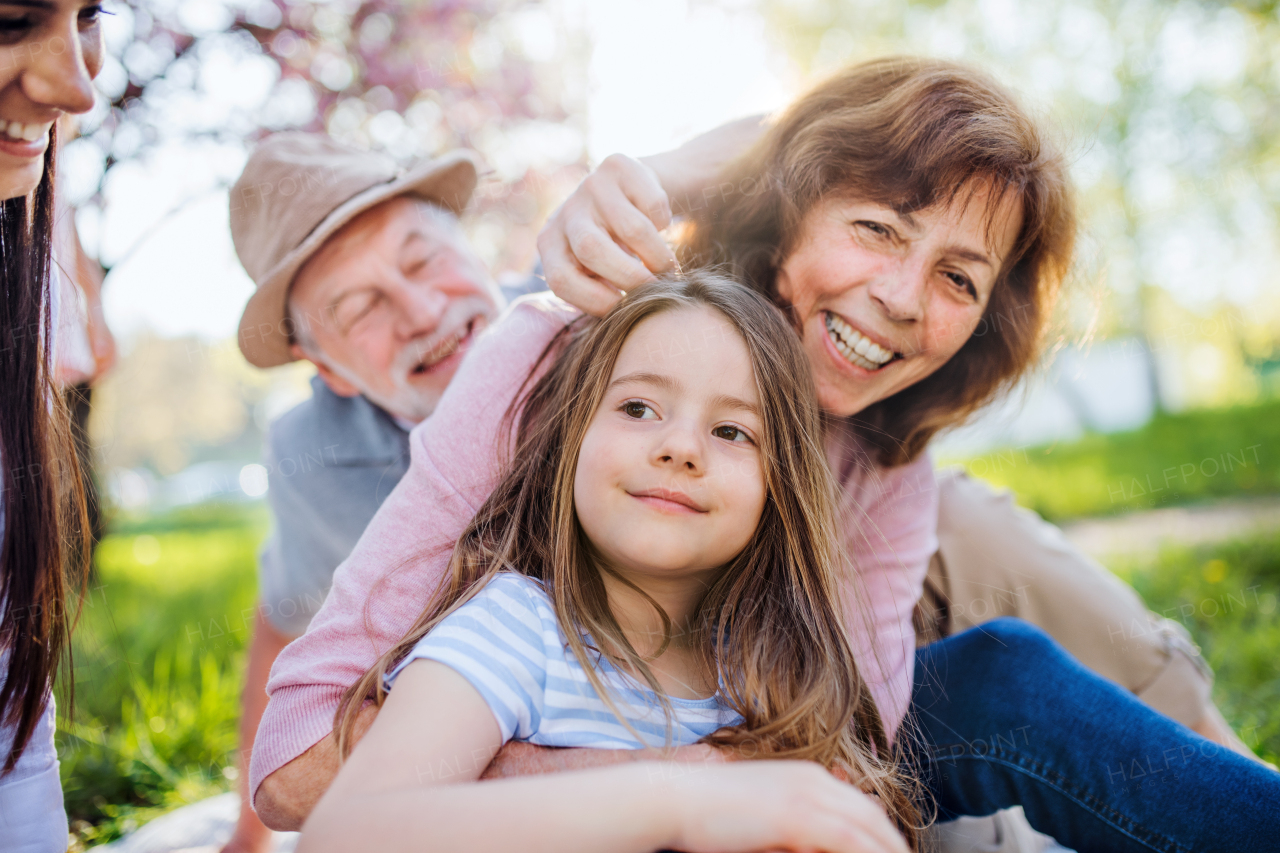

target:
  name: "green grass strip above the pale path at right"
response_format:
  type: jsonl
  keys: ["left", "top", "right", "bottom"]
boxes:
{"left": 957, "top": 400, "right": 1280, "bottom": 520}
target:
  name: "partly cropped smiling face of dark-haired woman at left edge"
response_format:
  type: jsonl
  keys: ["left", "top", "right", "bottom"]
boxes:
{"left": 0, "top": 0, "right": 102, "bottom": 199}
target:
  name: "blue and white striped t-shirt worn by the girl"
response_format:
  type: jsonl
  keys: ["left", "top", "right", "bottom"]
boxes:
{"left": 387, "top": 573, "right": 741, "bottom": 749}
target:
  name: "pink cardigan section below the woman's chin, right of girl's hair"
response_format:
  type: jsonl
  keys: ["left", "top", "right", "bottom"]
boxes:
{"left": 832, "top": 427, "right": 938, "bottom": 739}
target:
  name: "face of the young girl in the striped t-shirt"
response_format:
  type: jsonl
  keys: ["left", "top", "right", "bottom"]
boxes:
{"left": 573, "top": 306, "right": 764, "bottom": 576}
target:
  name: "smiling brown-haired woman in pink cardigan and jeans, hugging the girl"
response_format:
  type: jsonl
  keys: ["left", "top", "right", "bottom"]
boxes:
{"left": 251, "top": 60, "right": 1280, "bottom": 850}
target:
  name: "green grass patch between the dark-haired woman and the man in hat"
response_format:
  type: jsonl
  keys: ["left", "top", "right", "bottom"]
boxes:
{"left": 59, "top": 507, "right": 266, "bottom": 843}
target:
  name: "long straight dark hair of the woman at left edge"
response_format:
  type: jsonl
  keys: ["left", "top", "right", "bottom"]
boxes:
{"left": 0, "top": 126, "right": 88, "bottom": 775}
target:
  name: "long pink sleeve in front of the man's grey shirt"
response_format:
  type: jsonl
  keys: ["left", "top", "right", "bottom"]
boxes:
{"left": 250, "top": 296, "right": 575, "bottom": 797}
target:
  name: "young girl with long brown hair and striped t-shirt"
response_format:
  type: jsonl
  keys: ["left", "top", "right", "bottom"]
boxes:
{"left": 300, "top": 273, "right": 918, "bottom": 853}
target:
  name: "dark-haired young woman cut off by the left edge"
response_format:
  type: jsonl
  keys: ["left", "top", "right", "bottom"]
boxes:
{"left": 0, "top": 0, "right": 102, "bottom": 853}
